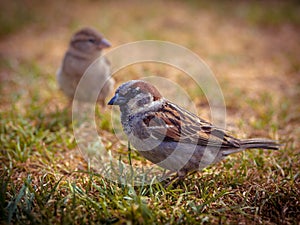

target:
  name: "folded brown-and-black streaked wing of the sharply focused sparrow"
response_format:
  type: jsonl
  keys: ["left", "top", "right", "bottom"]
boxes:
{"left": 143, "top": 102, "right": 240, "bottom": 148}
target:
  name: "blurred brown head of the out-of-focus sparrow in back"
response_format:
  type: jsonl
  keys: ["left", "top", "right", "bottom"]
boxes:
{"left": 70, "top": 27, "right": 111, "bottom": 54}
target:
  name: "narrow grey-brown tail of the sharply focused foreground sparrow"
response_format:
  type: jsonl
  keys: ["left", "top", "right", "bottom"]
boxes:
{"left": 223, "top": 138, "right": 280, "bottom": 156}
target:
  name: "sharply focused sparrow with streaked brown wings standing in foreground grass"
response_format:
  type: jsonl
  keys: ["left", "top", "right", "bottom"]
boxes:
{"left": 108, "top": 80, "right": 279, "bottom": 178}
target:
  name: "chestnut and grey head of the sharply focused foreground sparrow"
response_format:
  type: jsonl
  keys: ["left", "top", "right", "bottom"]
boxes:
{"left": 108, "top": 80, "right": 162, "bottom": 111}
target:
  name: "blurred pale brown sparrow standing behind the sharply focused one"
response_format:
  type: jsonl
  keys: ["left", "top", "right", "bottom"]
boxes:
{"left": 57, "top": 27, "right": 115, "bottom": 106}
